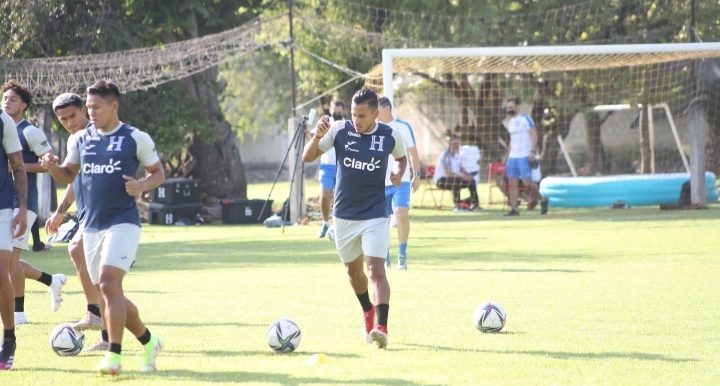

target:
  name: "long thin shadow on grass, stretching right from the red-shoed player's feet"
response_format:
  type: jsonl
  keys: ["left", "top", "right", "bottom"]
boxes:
{"left": 404, "top": 343, "right": 698, "bottom": 363}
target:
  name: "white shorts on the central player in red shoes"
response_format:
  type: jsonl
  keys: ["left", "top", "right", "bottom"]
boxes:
{"left": 333, "top": 217, "right": 390, "bottom": 264}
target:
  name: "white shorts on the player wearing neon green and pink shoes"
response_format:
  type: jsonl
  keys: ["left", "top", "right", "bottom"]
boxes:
{"left": 83, "top": 224, "right": 140, "bottom": 284}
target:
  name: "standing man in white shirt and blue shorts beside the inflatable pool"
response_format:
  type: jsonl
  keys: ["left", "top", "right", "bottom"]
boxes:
{"left": 505, "top": 97, "right": 548, "bottom": 216}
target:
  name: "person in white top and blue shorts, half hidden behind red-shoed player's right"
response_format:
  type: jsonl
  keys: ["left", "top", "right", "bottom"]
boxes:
{"left": 378, "top": 97, "right": 420, "bottom": 270}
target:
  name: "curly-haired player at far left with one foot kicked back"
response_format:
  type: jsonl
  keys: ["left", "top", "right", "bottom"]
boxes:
{"left": 0, "top": 80, "right": 67, "bottom": 324}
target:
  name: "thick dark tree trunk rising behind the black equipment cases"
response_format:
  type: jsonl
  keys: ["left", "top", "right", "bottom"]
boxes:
{"left": 161, "top": 15, "right": 247, "bottom": 198}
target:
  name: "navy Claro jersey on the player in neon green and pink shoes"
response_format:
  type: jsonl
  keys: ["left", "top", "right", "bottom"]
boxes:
{"left": 68, "top": 123, "right": 159, "bottom": 231}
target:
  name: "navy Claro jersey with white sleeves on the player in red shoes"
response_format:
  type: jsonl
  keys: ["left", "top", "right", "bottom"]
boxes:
{"left": 318, "top": 121, "right": 405, "bottom": 220}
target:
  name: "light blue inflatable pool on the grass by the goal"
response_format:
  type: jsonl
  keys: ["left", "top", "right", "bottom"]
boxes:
{"left": 540, "top": 172, "right": 718, "bottom": 207}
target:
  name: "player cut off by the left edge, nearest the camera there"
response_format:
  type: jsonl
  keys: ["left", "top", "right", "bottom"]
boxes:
{"left": 0, "top": 110, "right": 28, "bottom": 370}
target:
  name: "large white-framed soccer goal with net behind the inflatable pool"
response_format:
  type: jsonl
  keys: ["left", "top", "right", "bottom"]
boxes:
{"left": 367, "top": 43, "right": 720, "bottom": 206}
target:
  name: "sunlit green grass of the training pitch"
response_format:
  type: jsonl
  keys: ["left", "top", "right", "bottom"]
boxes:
{"left": 11, "top": 184, "right": 720, "bottom": 385}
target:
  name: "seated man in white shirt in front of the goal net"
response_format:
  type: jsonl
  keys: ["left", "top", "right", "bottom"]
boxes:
{"left": 434, "top": 135, "right": 480, "bottom": 212}
